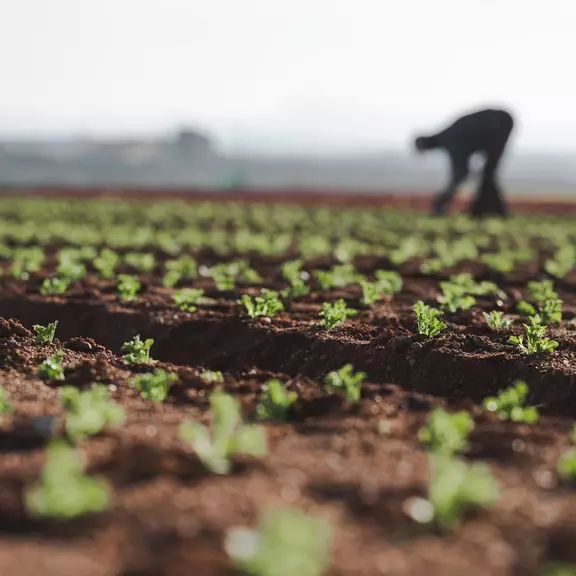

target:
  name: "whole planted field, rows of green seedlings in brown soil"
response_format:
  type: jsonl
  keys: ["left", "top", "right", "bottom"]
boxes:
{"left": 0, "top": 195, "right": 576, "bottom": 576}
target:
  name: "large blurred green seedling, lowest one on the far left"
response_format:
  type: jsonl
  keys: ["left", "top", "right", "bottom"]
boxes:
{"left": 24, "top": 440, "right": 112, "bottom": 519}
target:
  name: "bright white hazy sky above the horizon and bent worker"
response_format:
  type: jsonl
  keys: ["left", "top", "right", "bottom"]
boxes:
{"left": 0, "top": 0, "right": 576, "bottom": 151}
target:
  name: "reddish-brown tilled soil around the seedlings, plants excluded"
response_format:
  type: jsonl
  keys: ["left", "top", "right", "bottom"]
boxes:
{"left": 0, "top": 192, "right": 576, "bottom": 576}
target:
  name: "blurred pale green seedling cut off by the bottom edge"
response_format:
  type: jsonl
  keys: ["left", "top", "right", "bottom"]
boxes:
{"left": 225, "top": 508, "right": 332, "bottom": 576}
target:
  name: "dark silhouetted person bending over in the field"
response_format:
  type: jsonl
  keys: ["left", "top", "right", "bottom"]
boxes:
{"left": 415, "top": 109, "right": 514, "bottom": 217}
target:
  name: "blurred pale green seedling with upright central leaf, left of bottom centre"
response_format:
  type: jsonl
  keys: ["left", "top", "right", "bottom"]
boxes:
{"left": 180, "top": 390, "right": 267, "bottom": 474}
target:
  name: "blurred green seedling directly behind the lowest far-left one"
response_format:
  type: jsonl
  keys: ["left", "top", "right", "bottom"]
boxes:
{"left": 59, "top": 384, "right": 126, "bottom": 442}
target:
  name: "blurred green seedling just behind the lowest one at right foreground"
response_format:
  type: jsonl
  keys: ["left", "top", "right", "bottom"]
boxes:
{"left": 418, "top": 408, "right": 474, "bottom": 455}
